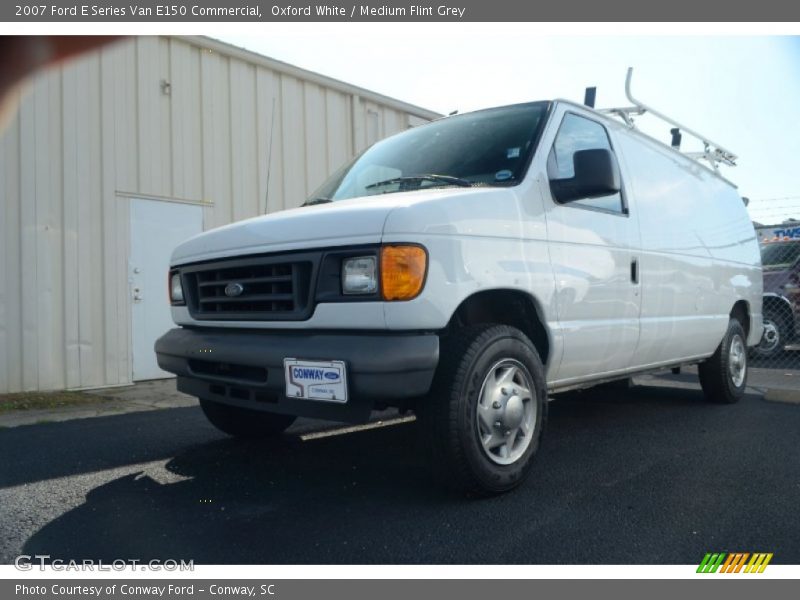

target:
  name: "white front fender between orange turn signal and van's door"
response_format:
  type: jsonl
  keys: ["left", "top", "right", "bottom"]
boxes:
{"left": 382, "top": 188, "right": 562, "bottom": 374}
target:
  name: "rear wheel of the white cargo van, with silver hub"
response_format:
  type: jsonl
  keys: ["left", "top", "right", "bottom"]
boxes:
{"left": 698, "top": 319, "right": 747, "bottom": 404}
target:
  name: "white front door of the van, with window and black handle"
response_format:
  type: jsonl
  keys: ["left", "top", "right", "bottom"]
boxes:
{"left": 542, "top": 105, "right": 640, "bottom": 384}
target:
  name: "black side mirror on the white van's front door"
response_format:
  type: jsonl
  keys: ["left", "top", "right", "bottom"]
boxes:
{"left": 550, "top": 148, "right": 622, "bottom": 202}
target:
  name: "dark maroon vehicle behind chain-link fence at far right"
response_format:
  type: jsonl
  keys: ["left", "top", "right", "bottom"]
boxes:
{"left": 753, "top": 239, "right": 800, "bottom": 358}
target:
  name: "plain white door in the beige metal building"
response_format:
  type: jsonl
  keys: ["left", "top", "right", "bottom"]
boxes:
{"left": 128, "top": 198, "right": 203, "bottom": 381}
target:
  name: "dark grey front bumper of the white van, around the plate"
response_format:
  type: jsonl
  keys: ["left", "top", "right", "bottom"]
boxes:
{"left": 155, "top": 328, "right": 439, "bottom": 422}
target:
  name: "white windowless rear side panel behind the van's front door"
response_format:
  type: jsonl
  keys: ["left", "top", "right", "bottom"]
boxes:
{"left": 616, "top": 131, "right": 762, "bottom": 365}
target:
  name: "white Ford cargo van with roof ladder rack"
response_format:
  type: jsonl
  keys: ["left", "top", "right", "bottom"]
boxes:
{"left": 156, "top": 78, "right": 762, "bottom": 493}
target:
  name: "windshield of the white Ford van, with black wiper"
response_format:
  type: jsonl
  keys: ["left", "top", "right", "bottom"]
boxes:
{"left": 307, "top": 102, "right": 548, "bottom": 204}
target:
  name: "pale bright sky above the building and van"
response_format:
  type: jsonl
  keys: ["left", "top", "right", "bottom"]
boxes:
{"left": 217, "top": 23, "right": 800, "bottom": 224}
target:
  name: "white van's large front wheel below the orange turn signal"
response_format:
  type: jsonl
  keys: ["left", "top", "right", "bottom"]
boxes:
{"left": 419, "top": 325, "right": 547, "bottom": 495}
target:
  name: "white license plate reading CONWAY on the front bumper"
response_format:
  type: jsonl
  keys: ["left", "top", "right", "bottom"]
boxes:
{"left": 283, "top": 358, "right": 347, "bottom": 403}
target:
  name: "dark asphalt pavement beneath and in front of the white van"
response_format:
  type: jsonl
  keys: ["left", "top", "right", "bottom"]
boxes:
{"left": 0, "top": 376, "right": 800, "bottom": 564}
